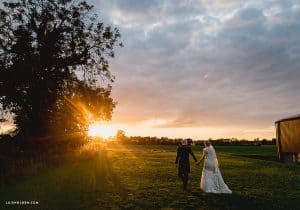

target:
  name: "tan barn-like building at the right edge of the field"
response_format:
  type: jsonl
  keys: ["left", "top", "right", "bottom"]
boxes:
{"left": 275, "top": 115, "right": 300, "bottom": 162}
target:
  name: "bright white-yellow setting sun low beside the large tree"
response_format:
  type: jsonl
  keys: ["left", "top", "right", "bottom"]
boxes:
{"left": 88, "top": 122, "right": 116, "bottom": 139}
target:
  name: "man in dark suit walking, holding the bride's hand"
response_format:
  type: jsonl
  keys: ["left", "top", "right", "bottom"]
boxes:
{"left": 175, "top": 139, "right": 197, "bottom": 190}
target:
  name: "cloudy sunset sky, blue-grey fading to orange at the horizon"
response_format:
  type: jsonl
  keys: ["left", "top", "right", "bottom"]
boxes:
{"left": 90, "top": 0, "right": 300, "bottom": 139}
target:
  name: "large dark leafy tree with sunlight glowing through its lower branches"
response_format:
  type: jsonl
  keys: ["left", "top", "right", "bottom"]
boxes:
{"left": 0, "top": 0, "right": 122, "bottom": 135}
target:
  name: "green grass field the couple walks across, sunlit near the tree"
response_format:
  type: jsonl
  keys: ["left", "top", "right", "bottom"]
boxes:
{"left": 0, "top": 143, "right": 300, "bottom": 210}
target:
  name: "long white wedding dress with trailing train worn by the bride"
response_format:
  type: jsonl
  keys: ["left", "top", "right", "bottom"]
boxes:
{"left": 200, "top": 146, "right": 232, "bottom": 193}
